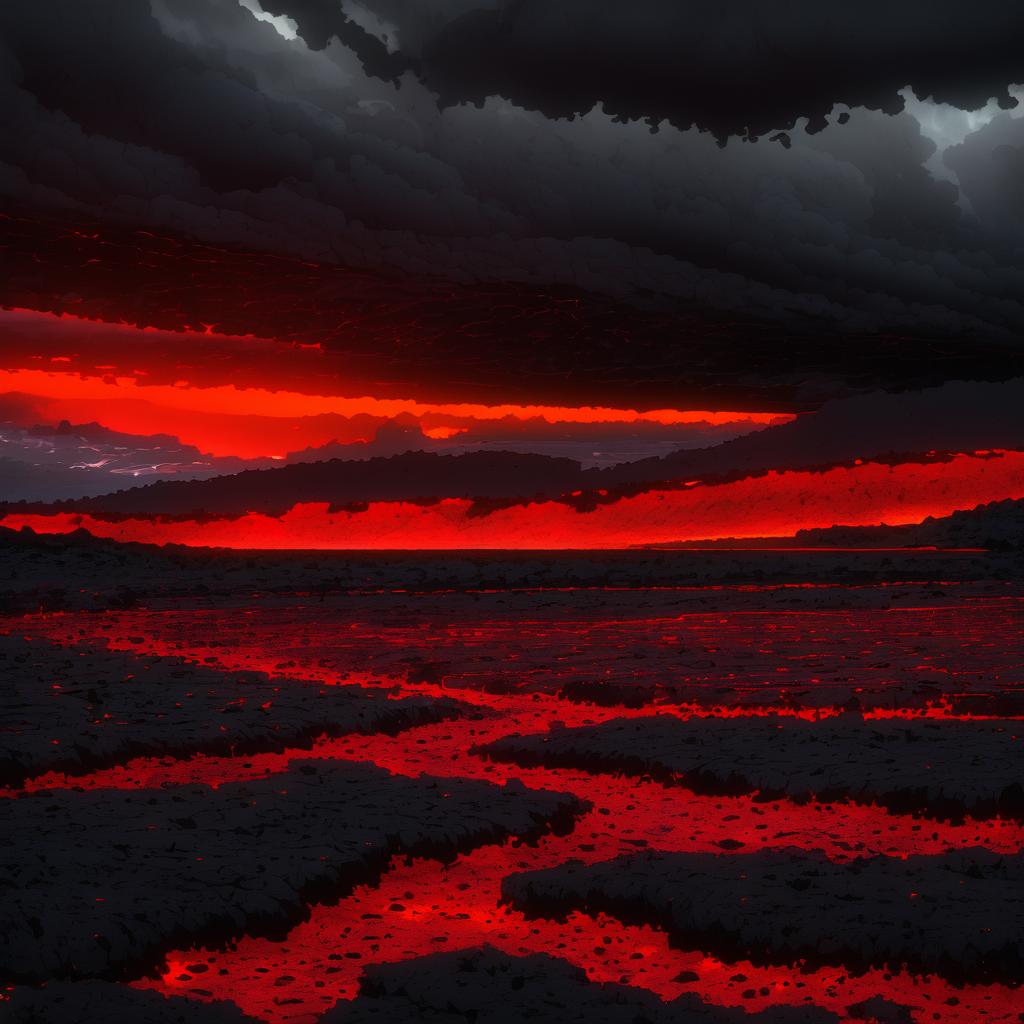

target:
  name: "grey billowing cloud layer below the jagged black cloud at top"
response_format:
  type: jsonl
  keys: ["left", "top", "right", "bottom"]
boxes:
{"left": 0, "top": 0, "right": 1024, "bottom": 343}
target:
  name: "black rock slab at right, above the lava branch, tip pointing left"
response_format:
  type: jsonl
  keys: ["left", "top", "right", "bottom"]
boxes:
{"left": 480, "top": 715, "right": 1024, "bottom": 819}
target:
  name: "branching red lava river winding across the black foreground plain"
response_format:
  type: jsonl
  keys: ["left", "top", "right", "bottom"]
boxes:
{"left": 5, "top": 563, "right": 1024, "bottom": 1024}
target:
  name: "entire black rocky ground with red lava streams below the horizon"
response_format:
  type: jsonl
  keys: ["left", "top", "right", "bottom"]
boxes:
{"left": 0, "top": 531, "right": 1024, "bottom": 1024}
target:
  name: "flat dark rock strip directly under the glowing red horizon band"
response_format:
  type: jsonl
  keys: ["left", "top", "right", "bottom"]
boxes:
{"left": 6, "top": 520, "right": 1024, "bottom": 614}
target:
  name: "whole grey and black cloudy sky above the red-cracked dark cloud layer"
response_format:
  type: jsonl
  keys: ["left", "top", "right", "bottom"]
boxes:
{"left": 0, "top": 0, "right": 1024, "bottom": 339}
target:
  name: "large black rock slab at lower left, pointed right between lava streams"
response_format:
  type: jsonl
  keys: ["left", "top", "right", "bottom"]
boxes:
{"left": 0, "top": 761, "right": 584, "bottom": 981}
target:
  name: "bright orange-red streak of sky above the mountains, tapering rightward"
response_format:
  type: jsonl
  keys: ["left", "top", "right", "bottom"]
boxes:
{"left": 0, "top": 309, "right": 794, "bottom": 458}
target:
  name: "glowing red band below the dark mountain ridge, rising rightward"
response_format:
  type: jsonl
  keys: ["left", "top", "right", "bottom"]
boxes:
{"left": 9, "top": 452, "right": 1024, "bottom": 551}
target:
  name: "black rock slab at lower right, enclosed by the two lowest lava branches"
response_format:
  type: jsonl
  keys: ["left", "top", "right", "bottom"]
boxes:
{"left": 502, "top": 848, "right": 1024, "bottom": 984}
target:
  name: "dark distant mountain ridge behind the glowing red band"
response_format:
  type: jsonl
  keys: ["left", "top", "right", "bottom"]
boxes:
{"left": 0, "top": 379, "right": 1024, "bottom": 517}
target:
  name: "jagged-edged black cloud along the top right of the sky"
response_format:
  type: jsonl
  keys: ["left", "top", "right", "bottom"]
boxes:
{"left": 272, "top": 0, "right": 1024, "bottom": 137}
